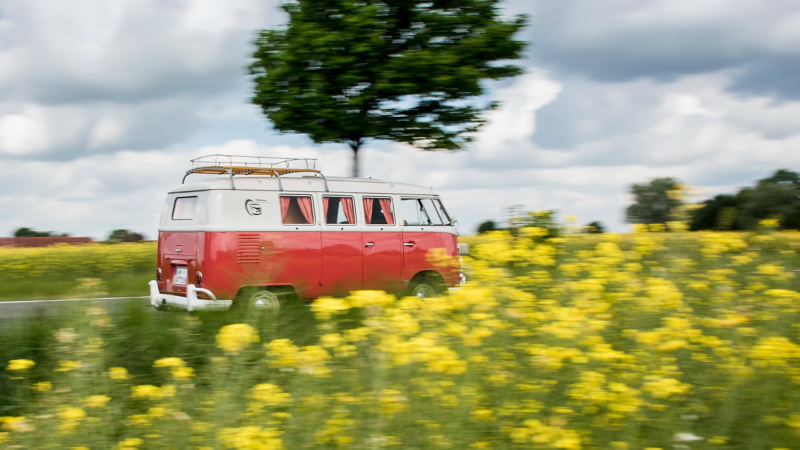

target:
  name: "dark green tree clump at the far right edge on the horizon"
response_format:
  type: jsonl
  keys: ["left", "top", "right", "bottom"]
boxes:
{"left": 690, "top": 169, "right": 800, "bottom": 230}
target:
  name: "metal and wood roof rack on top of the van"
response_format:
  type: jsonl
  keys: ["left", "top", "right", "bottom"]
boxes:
{"left": 181, "top": 155, "right": 328, "bottom": 192}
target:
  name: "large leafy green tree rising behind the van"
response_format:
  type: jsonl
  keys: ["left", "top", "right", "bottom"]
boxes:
{"left": 250, "top": 0, "right": 525, "bottom": 177}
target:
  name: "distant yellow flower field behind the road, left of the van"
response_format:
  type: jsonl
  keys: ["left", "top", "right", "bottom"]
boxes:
{"left": 0, "top": 242, "right": 156, "bottom": 301}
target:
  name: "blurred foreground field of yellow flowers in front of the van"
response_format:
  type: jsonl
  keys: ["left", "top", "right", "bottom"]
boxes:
{"left": 0, "top": 228, "right": 800, "bottom": 450}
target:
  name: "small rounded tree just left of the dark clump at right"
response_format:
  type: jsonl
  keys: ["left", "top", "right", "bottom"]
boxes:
{"left": 625, "top": 178, "right": 683, "bottom": 225}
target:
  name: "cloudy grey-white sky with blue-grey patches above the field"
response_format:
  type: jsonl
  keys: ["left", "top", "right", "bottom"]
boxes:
{"left": 0, "top": 0, "right": 800, "bottom": 238}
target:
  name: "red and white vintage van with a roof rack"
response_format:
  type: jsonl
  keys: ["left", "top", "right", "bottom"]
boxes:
{"left": 149, "top": 155, "right": 462, "bottom": 311}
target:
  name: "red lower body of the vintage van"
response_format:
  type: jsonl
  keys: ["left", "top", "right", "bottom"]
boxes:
{"left": 158, "top": 230, "right": 458, "bottom": 299}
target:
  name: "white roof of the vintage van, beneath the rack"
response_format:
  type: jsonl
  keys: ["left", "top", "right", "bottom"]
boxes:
{"left": 169, "top": 175, "right": 435, "bottom": 195}
